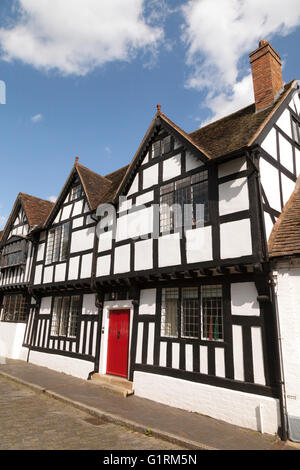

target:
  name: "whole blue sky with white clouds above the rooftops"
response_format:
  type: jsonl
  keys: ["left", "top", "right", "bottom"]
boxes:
{"left": 0, "top": 0, "right": 300, "bottom": 229}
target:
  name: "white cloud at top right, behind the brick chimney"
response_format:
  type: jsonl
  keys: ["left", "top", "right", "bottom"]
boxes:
{"left": 182, "top": 0, "right": 300, "bottom": 124}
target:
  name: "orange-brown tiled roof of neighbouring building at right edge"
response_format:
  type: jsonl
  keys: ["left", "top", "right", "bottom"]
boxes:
{"left": 268, "top": 177, "right": 300, "bottom": 258}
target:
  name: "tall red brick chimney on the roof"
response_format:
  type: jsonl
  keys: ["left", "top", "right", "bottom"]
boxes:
{"left": 249, "top": 40, "right": 283, "bottom": 111}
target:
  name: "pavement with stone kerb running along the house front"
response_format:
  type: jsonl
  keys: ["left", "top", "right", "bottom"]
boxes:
{"left": 0, "top": 359, "right": 300, "bottom": 450}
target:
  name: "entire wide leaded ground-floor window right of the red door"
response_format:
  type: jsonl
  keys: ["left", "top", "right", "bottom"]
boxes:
{"left": 161, "top": 285, "right": 224, "bottom": 341}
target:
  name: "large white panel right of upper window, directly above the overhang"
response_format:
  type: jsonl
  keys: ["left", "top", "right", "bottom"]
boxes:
{"left": 220, "top": 219, "right": 252, "bottom": 259}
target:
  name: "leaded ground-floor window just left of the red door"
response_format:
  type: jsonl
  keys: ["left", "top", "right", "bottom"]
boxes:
{"left": 51, "top": 295, "right": 81, "bottom": 338}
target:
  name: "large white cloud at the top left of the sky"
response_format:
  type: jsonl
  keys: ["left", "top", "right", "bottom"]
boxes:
{"left": 0, "top": 0, "right": 163, "bottom": 75}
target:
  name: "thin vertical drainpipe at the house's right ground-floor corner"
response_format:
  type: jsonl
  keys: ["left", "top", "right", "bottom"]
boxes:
{"left": 270, "top": 272, "right": 288, "bottom": 441}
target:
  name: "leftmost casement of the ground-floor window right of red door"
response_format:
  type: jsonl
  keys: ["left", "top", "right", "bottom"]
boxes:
{"left": 161, "top": 289, "right": 179, "bottom": 338}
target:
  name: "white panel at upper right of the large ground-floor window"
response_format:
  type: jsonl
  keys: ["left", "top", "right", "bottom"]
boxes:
{"left": 231, "top": 282, "right": 260, "bottom": 317}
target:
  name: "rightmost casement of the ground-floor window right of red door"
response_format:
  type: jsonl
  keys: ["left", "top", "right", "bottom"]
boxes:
{"left": 201, "top": 286, "right": 224, "bottom": 341}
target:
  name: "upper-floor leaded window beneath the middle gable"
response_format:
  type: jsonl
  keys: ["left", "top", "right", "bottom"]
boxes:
{"left": 46, "top": 222, "right": 70, "bottom": 264}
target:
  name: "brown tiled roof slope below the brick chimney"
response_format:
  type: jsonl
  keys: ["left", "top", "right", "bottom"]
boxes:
{"left": 189, "top": 80, "right": 296, "bottom": 158}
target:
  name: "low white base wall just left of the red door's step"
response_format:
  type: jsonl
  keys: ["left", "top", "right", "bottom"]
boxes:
{"left": 29, "top": 351, "right": 94, "bottom": 379}
